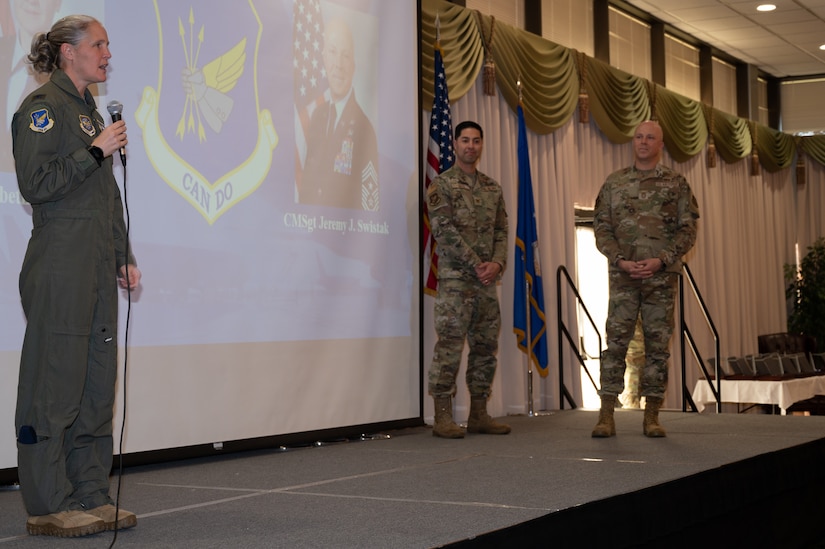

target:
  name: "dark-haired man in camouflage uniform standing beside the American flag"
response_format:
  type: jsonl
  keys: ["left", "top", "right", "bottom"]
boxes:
{"left": 427, "top": 121, "right": 510, "bottom": 438}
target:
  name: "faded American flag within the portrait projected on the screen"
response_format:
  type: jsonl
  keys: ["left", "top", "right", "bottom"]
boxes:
{"left": 292, "top": 0, "right": 327, "bottom": 196}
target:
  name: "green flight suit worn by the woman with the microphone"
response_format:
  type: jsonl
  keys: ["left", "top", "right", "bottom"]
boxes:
{"left": 12, "top": 70, "right": 134, "bottom": 515}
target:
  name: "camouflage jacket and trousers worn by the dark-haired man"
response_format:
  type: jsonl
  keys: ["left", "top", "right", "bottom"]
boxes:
{"left": 427, "top": 165, "right": 507, "bottom": 397}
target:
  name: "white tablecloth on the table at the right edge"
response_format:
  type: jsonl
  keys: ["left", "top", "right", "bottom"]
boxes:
{"left": 693, "top": 375, "right": 825, "bottom": 414}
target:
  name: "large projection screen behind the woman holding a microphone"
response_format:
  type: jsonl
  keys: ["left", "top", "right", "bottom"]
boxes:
{"left": 0, "top": 0, "right": 422, "bottom": 469}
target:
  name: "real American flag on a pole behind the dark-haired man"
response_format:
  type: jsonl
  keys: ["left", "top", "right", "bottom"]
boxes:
{"left": 424, "top": 42, "right": 455, "bottom": 295}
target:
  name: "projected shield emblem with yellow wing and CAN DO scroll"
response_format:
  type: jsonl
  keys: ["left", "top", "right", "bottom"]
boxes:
{"left": 136, "top": 0, "right": 278, "bottom": 225}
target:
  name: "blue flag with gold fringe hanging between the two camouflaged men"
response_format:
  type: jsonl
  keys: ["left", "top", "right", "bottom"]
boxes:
{"left": 513, "top": 104, "right": 547, "bottom": 377}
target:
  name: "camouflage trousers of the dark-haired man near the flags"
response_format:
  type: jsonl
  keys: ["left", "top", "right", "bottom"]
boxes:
{"left": 429, "top": 280, "right": 501, "bottom": 397}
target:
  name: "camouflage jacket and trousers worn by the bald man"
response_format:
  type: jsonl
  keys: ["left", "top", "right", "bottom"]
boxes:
{"left": 593, "top": 165, "right": 699, "bottom": 398}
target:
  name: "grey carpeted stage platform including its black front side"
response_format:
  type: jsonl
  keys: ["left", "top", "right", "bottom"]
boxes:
{"left": 0, "top": 410, "right": 825, "bottom": 549}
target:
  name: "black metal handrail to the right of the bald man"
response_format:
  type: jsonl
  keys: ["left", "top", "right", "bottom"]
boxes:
{"left": 679, "top": 263, "right": 722, "bottom": 413}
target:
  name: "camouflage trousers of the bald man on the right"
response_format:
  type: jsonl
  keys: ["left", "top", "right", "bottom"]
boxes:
{"left": 599, "top": 271, "right": 677, "bottom": 398}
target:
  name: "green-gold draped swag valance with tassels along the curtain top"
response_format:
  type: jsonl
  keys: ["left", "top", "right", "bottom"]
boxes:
{"left": 419, "top": 0, "right": 825, "bottom": 172}
